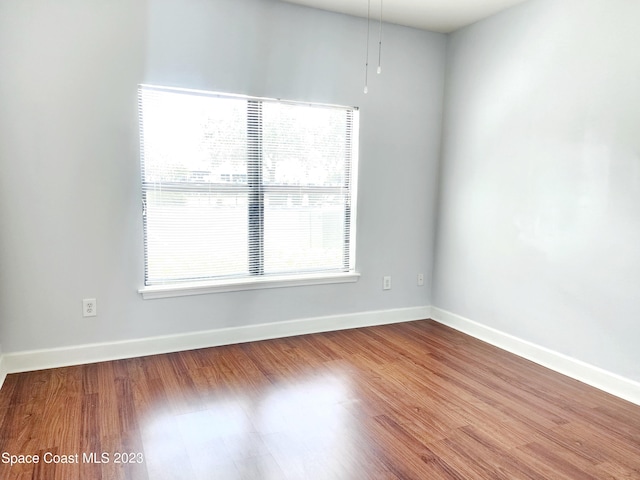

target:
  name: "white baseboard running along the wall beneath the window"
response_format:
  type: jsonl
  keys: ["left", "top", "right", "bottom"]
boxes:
{"left": 0, "top": 306, "right": 431, "bottom": 378}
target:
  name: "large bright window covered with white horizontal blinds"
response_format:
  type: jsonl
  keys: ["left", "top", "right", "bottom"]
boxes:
{"left": 139, "top": 85, "right": 358, "bottom": 293}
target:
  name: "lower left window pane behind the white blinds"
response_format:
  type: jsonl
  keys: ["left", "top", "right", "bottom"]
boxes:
{"left": 146, "top": 191, "right": 248, "bottom": 285}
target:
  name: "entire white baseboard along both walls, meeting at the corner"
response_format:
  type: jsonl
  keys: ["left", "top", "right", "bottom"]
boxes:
{"left": 5, "top": 306, "right": 640, "bottom": 405}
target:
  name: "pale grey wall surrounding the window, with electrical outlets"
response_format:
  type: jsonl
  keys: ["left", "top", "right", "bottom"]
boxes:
{"left": 0, "top": 0, "right": 446, "bottom": 354}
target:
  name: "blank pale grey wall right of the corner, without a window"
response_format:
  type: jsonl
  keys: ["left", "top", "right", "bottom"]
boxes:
{"left": 434, "top": 0, "right": 640, "bottom": 380}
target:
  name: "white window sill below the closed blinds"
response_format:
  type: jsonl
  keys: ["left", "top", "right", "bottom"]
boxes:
{"left": 138, "top": 273, "right": 360, "bottom": 300}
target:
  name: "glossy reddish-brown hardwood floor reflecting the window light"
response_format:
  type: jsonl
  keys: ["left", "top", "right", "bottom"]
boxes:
{"left": 0, "top": 320, "right": 640, "bottom": 480}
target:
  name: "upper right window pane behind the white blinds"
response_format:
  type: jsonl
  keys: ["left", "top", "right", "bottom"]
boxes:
{"left": 262, "top": 102, "right": 350, "bottom": 186}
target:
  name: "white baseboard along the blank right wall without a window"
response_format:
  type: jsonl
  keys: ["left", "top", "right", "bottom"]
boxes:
{"left": 431, "top": 307, "right": 640, "bottom": 405}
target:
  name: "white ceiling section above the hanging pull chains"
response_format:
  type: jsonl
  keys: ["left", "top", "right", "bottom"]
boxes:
{"left": 284, "top": 0, "right": 526, "bottom": 33}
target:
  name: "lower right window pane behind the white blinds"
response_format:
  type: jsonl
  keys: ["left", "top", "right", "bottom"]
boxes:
{"left": 264, "top": 192, "right": 345, "bottom": 274}
